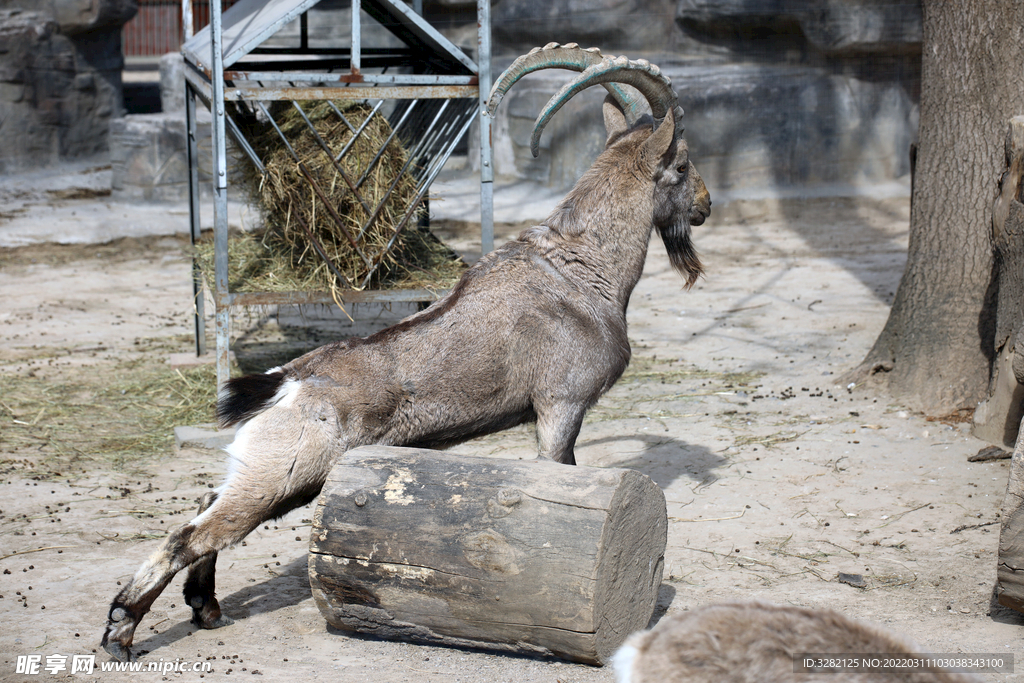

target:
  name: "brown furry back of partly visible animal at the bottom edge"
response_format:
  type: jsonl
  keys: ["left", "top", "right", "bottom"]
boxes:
{"left": 612, "top": 602, "right": 979, "bottom": 683}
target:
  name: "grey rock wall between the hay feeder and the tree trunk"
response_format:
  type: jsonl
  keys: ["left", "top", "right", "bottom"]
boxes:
{"left": 471, "top": 0, "right": 921, "bottom": 199}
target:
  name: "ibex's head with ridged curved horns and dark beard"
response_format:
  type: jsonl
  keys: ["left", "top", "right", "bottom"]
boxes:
{"left": 487, "top": 43, "right": 711, "bottom": 287}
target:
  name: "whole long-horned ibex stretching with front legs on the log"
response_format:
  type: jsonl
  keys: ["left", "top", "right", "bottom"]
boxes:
{"left": 102, "top": 44, "right": 711, "bottom": 659}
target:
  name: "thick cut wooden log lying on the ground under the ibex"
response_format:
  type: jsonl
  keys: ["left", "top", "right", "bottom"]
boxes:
{"left": 309, "top": 446, "right": 668, "bottom": 665}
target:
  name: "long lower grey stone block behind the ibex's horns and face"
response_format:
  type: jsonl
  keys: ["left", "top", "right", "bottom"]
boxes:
{"left": 481, "top": 60, "right": 918, "bottom": 199}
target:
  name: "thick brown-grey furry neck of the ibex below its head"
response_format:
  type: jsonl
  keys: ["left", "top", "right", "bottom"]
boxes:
{"left": 544, "top": 176, "right": 652, "bottom": 310}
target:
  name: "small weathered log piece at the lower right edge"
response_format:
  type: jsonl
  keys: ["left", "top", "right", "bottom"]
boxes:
{"left": 995, "top": 417, "right": 1024, "bottom": 612}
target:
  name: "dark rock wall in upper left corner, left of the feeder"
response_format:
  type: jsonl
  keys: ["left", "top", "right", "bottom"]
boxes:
{"left": 0, "top": 0, "right": 136, "bottom": 173}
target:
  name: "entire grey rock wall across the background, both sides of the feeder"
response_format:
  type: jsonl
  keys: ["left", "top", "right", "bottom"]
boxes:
{"left": 0, "top": 0, "right": 922, "bottom": 198}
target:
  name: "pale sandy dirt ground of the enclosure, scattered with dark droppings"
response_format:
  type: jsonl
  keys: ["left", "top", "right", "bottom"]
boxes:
{"left": 0, "top": 185, "right": 1024, "bottom": 683}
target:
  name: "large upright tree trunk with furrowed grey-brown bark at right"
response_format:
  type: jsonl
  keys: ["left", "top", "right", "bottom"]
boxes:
{"left": 850, "top": 0, "right": 1024, "bottom": 416}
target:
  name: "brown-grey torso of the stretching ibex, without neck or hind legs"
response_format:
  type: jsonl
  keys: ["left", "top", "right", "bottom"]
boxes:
{"left": 251, "top": 240, "right": 629, "bottom": 447}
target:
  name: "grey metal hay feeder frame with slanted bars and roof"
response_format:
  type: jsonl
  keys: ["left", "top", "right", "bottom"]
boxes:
{"left": 182, "top": 0, "right": 494, "bottom": 386}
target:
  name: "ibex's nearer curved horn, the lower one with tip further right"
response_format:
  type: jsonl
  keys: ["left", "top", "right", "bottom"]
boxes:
{"left": 529, "top": 56, "right": 683, "bottom": 157}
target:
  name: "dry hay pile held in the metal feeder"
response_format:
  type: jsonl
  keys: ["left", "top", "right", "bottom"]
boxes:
{"left": 197, "top": 101, "right": 466, "bottom": 292}
